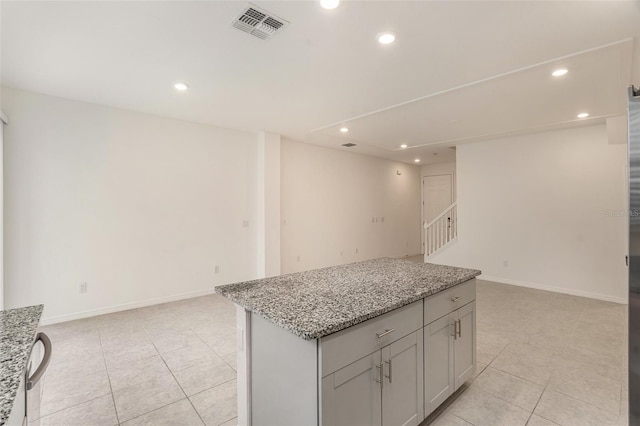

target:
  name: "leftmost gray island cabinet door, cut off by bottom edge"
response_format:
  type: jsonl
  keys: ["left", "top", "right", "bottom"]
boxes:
{"left": 321, "top": 351, "right": 382, "bottom": 426}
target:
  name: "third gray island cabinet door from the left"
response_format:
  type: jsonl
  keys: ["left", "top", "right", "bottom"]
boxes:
{"left": 424, "top": 313, "right": 456, "bottom": 416}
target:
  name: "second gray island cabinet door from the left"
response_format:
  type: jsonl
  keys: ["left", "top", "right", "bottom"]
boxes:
{"left": 382, "top": 330, "right": 424, "bottom": 426}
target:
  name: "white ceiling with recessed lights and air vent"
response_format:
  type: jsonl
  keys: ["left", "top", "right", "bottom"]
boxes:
{"left": 0, "top": 1, "right": 640, "bottom": 164}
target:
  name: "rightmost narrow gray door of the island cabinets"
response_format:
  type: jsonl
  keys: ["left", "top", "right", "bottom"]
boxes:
{"left": 454, "top": 302, "right": 476, "bottom": 389}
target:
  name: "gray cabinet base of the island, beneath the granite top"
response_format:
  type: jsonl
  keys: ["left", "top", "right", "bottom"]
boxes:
{"left": 238, "top": 280, "right": 476, "bottom": 426}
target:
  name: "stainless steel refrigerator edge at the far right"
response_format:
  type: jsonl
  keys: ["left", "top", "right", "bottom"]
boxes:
{"left": 629, "top": 86, "right": 640, "bottom": 426}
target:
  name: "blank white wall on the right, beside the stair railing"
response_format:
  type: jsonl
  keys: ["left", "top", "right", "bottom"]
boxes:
{"left": 430, "top": 125, "right": 628, "bottom": 303}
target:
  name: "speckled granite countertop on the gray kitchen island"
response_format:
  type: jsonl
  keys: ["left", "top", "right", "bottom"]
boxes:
{"left": 216, "top": 258, "right": 481, "bottom": 340}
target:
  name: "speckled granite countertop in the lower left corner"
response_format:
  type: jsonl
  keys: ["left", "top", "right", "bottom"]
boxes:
{"left": 0, "top": 305, "right": 44, "bottom": 425}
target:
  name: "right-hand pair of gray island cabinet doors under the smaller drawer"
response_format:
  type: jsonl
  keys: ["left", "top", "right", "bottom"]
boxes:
{"left": 424, "top": 302, "right": 476, "bottom": 416}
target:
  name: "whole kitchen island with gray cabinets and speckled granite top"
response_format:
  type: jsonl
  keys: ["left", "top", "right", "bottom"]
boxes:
{"left": 216, "top": 258, "right": 480, "bottom": 425}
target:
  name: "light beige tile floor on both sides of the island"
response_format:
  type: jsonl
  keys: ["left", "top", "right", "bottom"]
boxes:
{"left": 41, "top": 281, "right": 628, "bottom": 426}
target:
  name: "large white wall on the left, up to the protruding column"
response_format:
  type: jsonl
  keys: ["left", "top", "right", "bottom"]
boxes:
{"left": 2, "top": 88, "right": 259, "bottom": 323}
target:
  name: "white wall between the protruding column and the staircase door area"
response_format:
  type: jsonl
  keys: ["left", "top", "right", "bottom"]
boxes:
{"left": 281, "top": 139, "right": 421, "bottom": 273}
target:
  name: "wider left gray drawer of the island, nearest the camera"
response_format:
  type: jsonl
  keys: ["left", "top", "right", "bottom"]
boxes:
{"left": 320, "top": 300, "right": 422, "bottom": 377}
